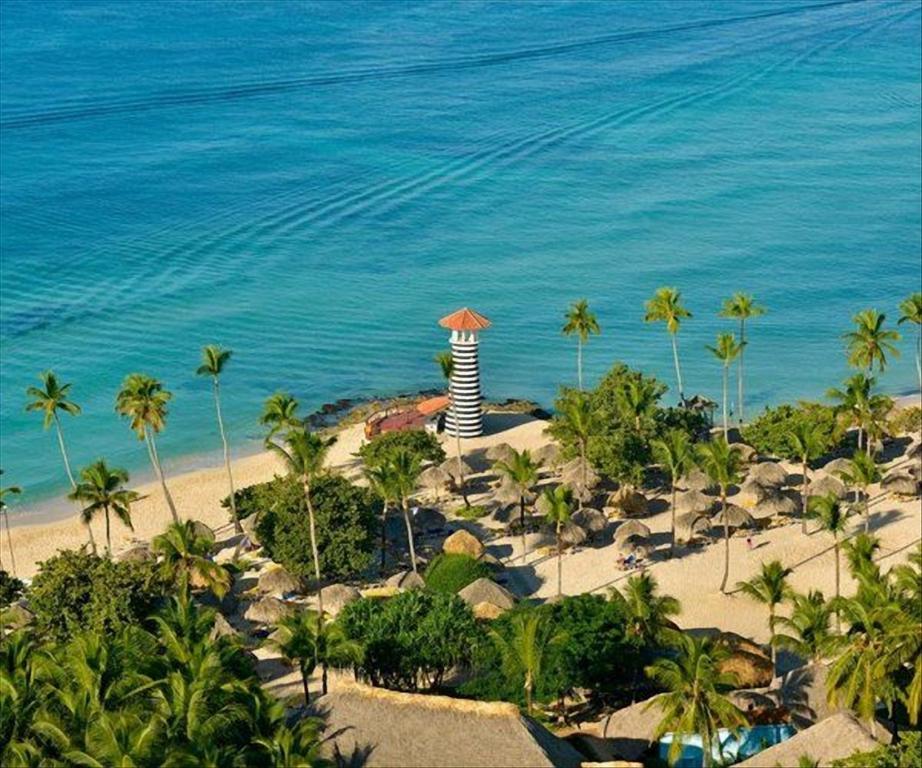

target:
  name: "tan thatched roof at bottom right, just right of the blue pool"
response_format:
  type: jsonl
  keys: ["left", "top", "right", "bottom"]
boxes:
{"left": 737, "top": 712, "right": 889, "bottom": 768}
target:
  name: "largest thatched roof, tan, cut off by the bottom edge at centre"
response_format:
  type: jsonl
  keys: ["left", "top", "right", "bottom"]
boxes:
{"left": 311, "top": 684, "right": 583, "bottom": 768}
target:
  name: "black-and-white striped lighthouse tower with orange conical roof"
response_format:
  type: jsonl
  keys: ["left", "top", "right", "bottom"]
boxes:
{"left": 439, "top": 307, "right": 490, "bottom": 437}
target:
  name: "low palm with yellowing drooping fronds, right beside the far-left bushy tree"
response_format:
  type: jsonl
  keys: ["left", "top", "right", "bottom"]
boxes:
{"left": 151, "top": 520, "right": 232, "bottom": 598}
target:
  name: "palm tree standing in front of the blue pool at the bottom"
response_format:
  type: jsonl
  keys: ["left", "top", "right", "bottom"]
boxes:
{"left": 646, "top": 634, "right": 747, "bottom": 766}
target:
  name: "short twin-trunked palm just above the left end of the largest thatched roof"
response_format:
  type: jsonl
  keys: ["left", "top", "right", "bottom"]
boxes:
{"left": 269, "top": 610, "right": 361, "bottom": 704}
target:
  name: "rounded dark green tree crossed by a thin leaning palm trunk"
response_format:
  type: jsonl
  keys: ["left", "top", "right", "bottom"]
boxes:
{"left": 252, "top": 474, "right": 379, "bottom": 579}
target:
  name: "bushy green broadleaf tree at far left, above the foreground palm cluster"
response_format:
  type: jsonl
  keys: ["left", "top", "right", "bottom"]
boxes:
{"left": 28, "top": 548, "right": 166, "bottom": 640}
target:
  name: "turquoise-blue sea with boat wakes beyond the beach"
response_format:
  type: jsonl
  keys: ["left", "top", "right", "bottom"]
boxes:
{"left": 0, "top": 0, "right": 922, "bottom": 509}
